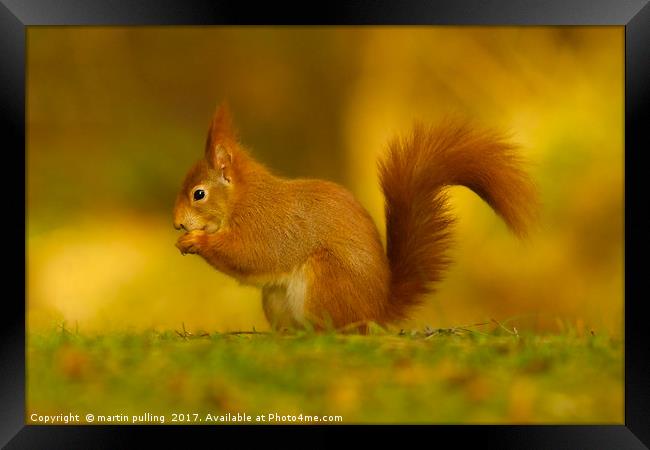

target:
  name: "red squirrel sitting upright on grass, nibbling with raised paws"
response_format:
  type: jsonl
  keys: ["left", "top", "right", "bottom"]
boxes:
{"left": 174, "top": 104, "right": 537, "bottom": 333}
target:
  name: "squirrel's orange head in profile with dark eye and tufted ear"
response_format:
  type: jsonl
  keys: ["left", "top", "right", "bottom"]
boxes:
{"left": 174, "top": 104, "right": 243, "bottom": 233}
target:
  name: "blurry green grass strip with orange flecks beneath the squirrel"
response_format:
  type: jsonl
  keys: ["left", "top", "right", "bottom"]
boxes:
{"left": 27, "top": 327, "right": 623, "bottom": 423}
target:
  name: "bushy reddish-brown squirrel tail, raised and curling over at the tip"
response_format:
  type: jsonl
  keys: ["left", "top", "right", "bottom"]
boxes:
{"left": 379, "top": 121, "right": 537, "bottom": 321}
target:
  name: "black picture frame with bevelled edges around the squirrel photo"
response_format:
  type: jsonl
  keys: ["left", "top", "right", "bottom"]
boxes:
{"left": 0, "top": 0, "right": 650, "bottom": 449}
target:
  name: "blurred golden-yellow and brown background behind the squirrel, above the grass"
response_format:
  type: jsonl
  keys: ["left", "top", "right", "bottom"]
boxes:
{"left": 27, "top": 27, "right": 624, "bottom": 336}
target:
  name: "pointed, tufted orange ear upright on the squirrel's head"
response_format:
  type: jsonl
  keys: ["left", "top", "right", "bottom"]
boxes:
{"left": 205, "top": 102, "right": 237, "bottom": 183}
